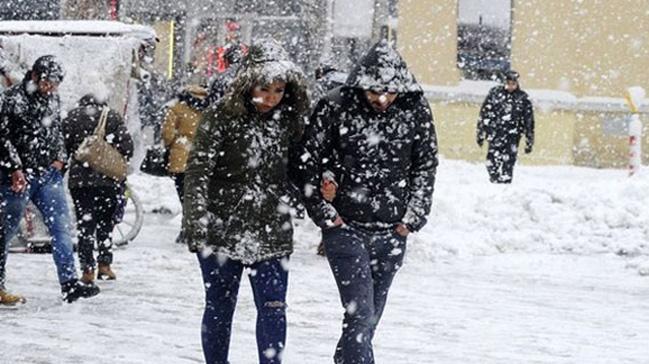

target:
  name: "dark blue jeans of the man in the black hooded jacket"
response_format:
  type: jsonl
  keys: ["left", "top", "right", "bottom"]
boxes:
{"left": 322, "top": 226, "right": 406, "bottom": 364}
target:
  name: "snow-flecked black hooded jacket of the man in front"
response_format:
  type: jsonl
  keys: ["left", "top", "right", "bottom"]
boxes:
{"left": 300, "top": 42, "right": 438, "bottom": 231}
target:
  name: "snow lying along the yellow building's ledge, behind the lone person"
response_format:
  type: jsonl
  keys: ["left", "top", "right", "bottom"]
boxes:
{"left": 423, "top": 80, "right": 649, "bottom": 112}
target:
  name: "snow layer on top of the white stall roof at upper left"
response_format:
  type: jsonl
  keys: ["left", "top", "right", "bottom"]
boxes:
{"left": 0, "top": 20, "right": 156, "bottom": 40}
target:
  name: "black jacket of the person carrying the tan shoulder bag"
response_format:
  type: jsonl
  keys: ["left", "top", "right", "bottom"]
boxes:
{"left": 62, "top": 95, "right": 133, "bottom": 188}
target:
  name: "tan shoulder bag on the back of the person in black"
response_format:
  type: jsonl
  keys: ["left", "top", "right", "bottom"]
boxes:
{"left": 74, "top": 107, "right": 128, "bottom": 182}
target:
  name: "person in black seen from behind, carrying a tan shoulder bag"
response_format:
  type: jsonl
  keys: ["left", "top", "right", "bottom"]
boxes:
{"left": 62, "top": 94, "right": 133, "bottom": 284}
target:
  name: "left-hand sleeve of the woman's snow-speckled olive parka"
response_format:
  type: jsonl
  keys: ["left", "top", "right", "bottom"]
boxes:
{"left": 183, "top": 112, "right": 223, "bottom": 252}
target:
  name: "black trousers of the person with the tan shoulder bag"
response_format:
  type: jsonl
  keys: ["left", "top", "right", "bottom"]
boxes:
{"left": 70, "top": 186, "right": 124, "bottom": 270}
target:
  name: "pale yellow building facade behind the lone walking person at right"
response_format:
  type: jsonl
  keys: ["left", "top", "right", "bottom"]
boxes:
{"left": 398, "top": 0, "right": 649, "bottom": 167}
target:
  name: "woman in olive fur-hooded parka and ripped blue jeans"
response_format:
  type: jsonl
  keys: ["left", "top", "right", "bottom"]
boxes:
{"left": 183, "top": 41, "right": 309, "bottom": 364}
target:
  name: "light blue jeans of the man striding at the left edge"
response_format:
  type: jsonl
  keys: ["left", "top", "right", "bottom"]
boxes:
{"left": 0, "top": 168, "right": 77, "bottom": 288}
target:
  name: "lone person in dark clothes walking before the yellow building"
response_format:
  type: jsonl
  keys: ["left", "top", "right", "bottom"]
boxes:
{"left": 476, "top": 71, "right": 534, "bottom": 183}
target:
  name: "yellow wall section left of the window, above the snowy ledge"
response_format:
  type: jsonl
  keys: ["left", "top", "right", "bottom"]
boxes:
{"left": 397, "top": 0, "right": 460, "bottom": 85}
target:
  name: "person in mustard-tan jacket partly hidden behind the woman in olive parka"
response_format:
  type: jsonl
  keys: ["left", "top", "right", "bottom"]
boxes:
{"left": 162, "top": 86, "right": 207, "bottom": 243}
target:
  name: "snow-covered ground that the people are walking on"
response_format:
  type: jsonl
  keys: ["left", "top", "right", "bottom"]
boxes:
{"left": 0, "top": 160, "right": 649, "bottom": 364}
